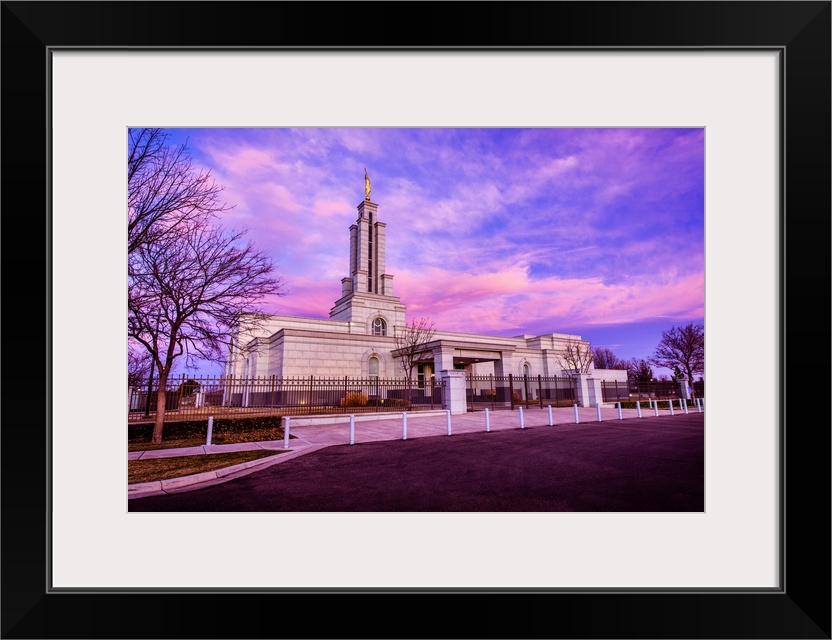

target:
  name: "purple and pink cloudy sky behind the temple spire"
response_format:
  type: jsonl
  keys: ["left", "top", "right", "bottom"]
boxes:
{"left": 158, "top": 128, "right": 705, "bottom": 375}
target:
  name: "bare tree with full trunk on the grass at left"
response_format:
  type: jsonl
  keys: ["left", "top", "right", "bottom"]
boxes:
{"left": 127, "top": 222, "right": 284, "bottom": 443}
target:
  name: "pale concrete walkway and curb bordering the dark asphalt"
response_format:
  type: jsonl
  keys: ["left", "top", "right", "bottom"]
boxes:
{"left": 128, "top": 405, "right": 698, "bottom": 498}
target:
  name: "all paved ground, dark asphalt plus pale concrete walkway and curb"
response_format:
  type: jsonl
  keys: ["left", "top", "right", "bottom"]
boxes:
{"left": 128, "top": 407, "right": 705, "bottom": 512}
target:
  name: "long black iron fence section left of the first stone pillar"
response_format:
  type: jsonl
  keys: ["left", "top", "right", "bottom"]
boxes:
{"left": 128, "top": 375, "right": 444, "bottom": 422}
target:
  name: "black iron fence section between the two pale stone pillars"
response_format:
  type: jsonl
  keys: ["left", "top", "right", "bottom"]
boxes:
{"left": 466, "top": 374, "right": 578, "bottom": 411}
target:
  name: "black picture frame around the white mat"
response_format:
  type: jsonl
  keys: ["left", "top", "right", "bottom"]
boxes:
{"left": 0, "top": 1, "right": 832, "bottom": 638}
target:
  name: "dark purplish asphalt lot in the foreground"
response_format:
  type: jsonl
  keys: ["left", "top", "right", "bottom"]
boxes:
{"left": 128, "top": 412, "right": 705, "bottom": 512}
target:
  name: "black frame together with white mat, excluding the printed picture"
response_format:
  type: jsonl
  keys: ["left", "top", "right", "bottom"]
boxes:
{"left": 0, "top": 2, "right": 832, "bottom": 638}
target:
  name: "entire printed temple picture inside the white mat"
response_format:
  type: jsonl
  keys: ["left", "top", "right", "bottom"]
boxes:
{"left": 127, "top": 127, "right": 705, "bottom": 512}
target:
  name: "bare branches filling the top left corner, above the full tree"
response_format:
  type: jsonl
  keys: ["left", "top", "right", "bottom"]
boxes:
{"left": 127, "top": 129, "right": 232, "bottom": 254}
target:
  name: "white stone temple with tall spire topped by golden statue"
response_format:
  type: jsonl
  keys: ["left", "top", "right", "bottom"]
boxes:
{"left": 225, "top": 172, "right": 626, "bottom": 404}
